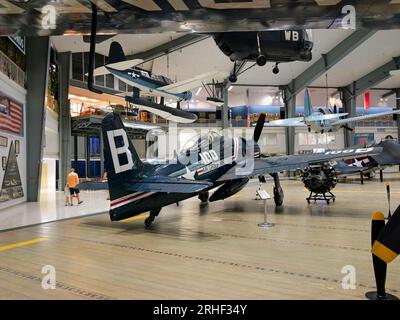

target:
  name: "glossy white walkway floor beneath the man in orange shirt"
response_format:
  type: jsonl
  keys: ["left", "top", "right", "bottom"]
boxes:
{"left": 0, "top": 190, "right": 109, "bottom": 230}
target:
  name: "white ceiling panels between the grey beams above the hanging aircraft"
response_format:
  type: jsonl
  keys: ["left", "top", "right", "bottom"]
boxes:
{"left": 52, "top": 29, "right": 400, "bottom": 105}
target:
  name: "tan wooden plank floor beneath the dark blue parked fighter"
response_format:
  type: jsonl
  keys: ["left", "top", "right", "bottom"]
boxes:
{"left": 0, "top": 175, "right": 400, "bottom": 299}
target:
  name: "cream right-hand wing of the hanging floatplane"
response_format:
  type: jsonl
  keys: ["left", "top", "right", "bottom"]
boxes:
{"left": 157, "top": 71, "right": 229, "bottom": 94}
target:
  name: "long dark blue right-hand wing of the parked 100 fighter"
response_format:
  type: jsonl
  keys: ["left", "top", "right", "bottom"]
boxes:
{"left": 218, "top": 147, "right": 382, "bottom": 181}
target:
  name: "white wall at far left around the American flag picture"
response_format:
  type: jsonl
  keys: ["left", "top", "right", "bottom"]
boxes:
{"left": 0, "top": 72, "right": 26, "bottom": 210}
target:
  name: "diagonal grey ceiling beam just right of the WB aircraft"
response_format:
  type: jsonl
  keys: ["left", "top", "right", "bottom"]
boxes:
{"left": 285, "top": 29, "right": 376, "bottom": 98}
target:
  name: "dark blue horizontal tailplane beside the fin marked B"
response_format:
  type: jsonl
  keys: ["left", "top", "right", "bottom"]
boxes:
{"left": 124, "top": 176, "right": 213, "bottom": 193}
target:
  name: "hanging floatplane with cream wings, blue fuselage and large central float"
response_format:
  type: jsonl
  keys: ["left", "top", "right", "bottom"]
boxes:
{"left": 93, "top": 41, "right": 228, "bottom": 123}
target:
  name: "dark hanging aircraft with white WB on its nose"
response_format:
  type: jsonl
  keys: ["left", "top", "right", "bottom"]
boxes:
{"left": 213, "top": 29, "right": 314, "bottom": 83}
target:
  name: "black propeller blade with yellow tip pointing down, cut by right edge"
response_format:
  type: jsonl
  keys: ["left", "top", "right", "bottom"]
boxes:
{"left": 372, "top": 206, "right": 400, "bottom": 263}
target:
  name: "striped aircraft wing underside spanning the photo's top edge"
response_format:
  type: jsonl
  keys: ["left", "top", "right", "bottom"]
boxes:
{"left": 0, "top": 0, "right": 400, "bottom": 36}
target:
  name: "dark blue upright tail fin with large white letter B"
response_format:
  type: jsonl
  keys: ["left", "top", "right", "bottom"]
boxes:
{"left": 102, "top": 113, "right": 144, "bottom": 201}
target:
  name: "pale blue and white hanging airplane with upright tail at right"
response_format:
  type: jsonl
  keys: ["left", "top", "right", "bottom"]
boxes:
{"left": 265, "top": 89, "right": 400, "bottom": 133}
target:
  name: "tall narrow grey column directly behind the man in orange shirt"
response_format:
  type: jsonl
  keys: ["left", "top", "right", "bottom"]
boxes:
{"left": 57, "top": 52, "right": 71, "bottom": 191}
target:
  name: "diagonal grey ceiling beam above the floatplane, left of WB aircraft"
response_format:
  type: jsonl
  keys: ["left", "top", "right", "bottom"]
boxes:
{"left": 126, "top": 34, "right": 209, "bottom": 62}
